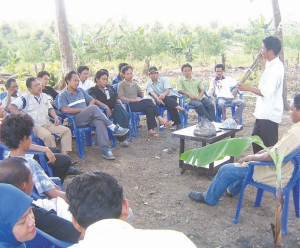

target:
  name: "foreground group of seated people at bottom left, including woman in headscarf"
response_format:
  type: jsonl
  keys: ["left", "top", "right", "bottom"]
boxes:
{"left": 0, "top": 113, "right": 196, "bottom": 247}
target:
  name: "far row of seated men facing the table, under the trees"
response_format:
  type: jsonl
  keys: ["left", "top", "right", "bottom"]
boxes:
{"left": 2, "top": 63, "right": 245, "bottom": 160}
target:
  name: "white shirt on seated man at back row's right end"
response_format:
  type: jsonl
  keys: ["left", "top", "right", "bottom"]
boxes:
{"left": 209, "top": 76, "right": 237, "bottom": 98}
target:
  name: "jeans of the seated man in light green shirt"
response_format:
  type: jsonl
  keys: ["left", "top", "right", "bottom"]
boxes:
{"left": 189, "top": 98, "right": 216, "bottom": 121}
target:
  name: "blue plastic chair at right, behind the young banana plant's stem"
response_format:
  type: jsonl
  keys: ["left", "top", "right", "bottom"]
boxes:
{"left": 232, "top": 149, "right": 300, "bottom": 235}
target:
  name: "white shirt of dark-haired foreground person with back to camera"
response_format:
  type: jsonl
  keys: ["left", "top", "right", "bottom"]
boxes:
{"left": 71, "top": 219, "right": 196, "bottom": 248}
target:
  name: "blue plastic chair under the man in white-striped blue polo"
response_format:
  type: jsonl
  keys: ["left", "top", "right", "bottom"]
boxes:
{"left": 55, "top": 94, "right": 117, "bottom": 159}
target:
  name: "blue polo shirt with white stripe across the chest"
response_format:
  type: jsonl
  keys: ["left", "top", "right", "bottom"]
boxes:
{"left": 58, "top": 88, "right": 93, "bottom": 116}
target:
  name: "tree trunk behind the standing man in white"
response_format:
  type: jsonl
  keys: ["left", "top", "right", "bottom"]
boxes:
{"left": 272, "top": 0, "right": 290, "bottom": 110}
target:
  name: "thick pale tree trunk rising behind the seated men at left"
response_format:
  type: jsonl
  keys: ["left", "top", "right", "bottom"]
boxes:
{"left": 55, "top": 0, "right": 75, "bottom": 90}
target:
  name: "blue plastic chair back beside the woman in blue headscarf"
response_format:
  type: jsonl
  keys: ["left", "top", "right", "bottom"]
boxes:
{"left": 25, "top": 228, "right": 74, "bottom": 248}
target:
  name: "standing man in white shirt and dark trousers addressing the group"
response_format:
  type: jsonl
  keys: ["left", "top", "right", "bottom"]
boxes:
{"left": 237, "top": 36, "right": 284, "bottom": 153}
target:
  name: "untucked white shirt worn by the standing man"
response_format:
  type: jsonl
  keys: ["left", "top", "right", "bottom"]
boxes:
{"left": 254, "top": 57, "right": 284, "bottom": 123}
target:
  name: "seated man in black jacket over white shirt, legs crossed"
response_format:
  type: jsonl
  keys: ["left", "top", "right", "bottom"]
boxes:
{"left": 88, "top": 69, "right": 130, "bottom": 147}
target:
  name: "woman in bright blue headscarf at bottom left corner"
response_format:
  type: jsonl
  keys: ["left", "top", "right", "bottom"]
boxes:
{"left": 0, "top": 183, "right": 36, "bottom": 247}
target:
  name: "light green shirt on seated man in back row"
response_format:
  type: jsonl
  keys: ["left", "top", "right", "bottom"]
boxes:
{"left": 177, "top": 77, "right": 205, "bottom": 103}
